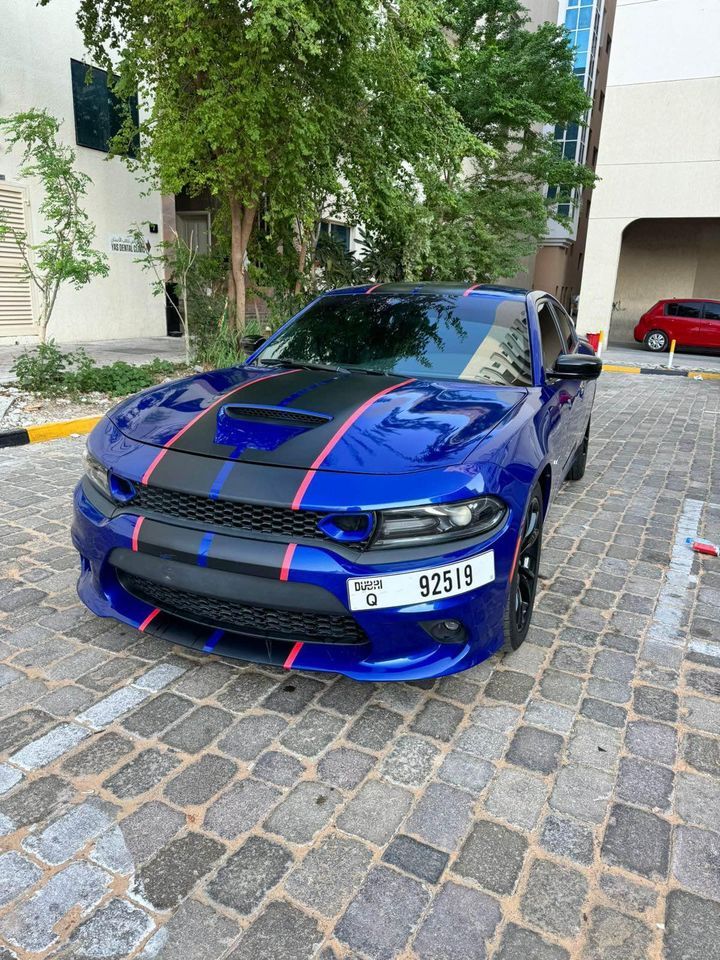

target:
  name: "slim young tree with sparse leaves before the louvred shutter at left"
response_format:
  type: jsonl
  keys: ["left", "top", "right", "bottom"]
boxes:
{"left": 0, "top": 110, "right": 109, "bottom": 343}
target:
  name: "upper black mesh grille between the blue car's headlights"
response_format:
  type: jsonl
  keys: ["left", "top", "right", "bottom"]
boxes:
{"left": 132, "top": 485, "right": 323, "bottom": 540}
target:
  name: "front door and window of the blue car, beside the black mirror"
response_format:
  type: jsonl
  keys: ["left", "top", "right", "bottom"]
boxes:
{"left": 537, "top": 300, "right": 582, "bottom": 495}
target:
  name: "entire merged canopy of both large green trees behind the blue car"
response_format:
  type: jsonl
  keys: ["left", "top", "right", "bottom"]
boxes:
{"left": 52, "top": 0, "right": 593, "bottom": 330}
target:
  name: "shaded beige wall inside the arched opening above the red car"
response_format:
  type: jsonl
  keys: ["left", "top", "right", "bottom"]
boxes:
{"left": 610, "top": 220, "right": 720, "bottom": 343}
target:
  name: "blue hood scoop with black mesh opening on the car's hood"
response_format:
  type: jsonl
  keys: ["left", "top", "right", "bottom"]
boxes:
{"left": 215, "top": 403, "right": 332, "bottom": 459}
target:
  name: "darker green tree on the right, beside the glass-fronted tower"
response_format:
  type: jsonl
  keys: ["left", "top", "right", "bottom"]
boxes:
{"left": 362, "top": 0, "right": 595, "bottom": 281}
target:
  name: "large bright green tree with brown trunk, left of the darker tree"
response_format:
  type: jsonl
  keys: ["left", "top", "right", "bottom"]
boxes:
{"left": 66, "top": 0, "right": 457, "bottom": 330}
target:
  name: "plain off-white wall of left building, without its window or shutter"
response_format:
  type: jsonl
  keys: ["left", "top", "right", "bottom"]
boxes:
{"left": 0, "top": 0, "right": 165, "bottom": 341}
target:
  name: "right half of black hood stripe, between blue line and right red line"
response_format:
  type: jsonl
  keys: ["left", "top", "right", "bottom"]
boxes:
{"left": 240, "top": 374, "right": 401, "bottom": 470}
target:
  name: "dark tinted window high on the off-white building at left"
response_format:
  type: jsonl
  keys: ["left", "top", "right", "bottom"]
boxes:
{"left": 70, "top": 60, "right": 139, "bottom": 157}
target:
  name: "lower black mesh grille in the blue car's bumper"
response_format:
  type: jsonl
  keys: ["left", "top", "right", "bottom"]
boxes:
{"left": 117, "top": 570, "right": 368, "bottom": 644}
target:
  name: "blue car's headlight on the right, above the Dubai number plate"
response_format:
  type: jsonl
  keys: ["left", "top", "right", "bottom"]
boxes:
{"left": 373, "top": 497, "right": 507, "bottom": 547}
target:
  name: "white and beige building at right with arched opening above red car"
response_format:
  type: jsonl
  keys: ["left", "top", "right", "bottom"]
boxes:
{"left": 578, "top": 0, "right": 720, "bottom": 343}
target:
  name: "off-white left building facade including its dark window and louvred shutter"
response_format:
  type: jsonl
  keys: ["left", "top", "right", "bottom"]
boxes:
{"left": 0, "top": 0, "right": 166, "bottom": 343}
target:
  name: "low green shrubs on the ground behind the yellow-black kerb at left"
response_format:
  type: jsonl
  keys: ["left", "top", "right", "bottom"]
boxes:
{"left": 11, "top": 340, "right": 178, "bottom": 397}
